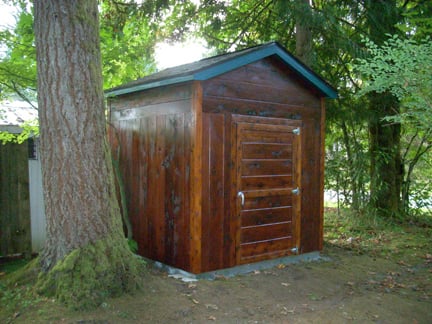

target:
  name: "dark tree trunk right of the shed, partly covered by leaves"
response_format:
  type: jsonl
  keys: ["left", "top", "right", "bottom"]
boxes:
{"left": 365, "top": 0, "right": 403, "bottom": 217}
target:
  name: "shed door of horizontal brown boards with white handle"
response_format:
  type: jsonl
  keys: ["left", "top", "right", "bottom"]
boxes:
{"left": 233, "top": 118, "right": 301, "bottom": 264}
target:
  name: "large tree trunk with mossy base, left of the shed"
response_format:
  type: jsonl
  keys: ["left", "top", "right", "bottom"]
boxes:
{"left": 34, "top": 0, "right": 142, "bottom": 306}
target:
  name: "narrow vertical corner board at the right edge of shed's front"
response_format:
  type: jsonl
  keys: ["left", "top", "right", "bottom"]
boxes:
{"left": 318, "top": 98, "right": 325, "bottom": 251}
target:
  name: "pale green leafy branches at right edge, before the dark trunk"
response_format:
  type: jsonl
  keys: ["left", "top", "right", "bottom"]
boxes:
{"left": 356, "top": 35, "right": 432, "bottom": 130}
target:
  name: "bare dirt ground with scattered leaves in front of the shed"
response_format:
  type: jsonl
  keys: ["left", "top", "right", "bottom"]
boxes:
{"left": 0, "top": 243, "right": 432, "bottom": 324}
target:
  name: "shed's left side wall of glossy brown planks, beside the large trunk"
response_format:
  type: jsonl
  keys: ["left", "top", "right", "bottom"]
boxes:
{"left": 109, "top": 85, "right": 192, "bottom": 270}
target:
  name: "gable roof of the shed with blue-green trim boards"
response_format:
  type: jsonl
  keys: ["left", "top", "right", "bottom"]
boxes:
{"left": 106, "top": 42, "right": 337, "bottom": 99}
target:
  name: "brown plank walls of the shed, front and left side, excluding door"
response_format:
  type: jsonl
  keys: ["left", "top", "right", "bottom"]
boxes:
{"left": 109, "top": 57, "right": 325, "bottom": 273}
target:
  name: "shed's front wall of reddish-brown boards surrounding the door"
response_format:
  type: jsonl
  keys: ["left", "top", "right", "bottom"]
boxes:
{"left": 203, "top": 58, "right": 324, "bottom": 260}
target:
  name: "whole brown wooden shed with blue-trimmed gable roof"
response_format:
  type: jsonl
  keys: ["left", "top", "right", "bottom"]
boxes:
{"left": 107, "top": 42, "right": 337, "bottom": 274}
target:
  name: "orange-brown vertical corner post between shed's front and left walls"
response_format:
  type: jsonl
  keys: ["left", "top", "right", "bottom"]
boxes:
{"left": 190, "top": 81, "right": 202, "bottom": 273}
